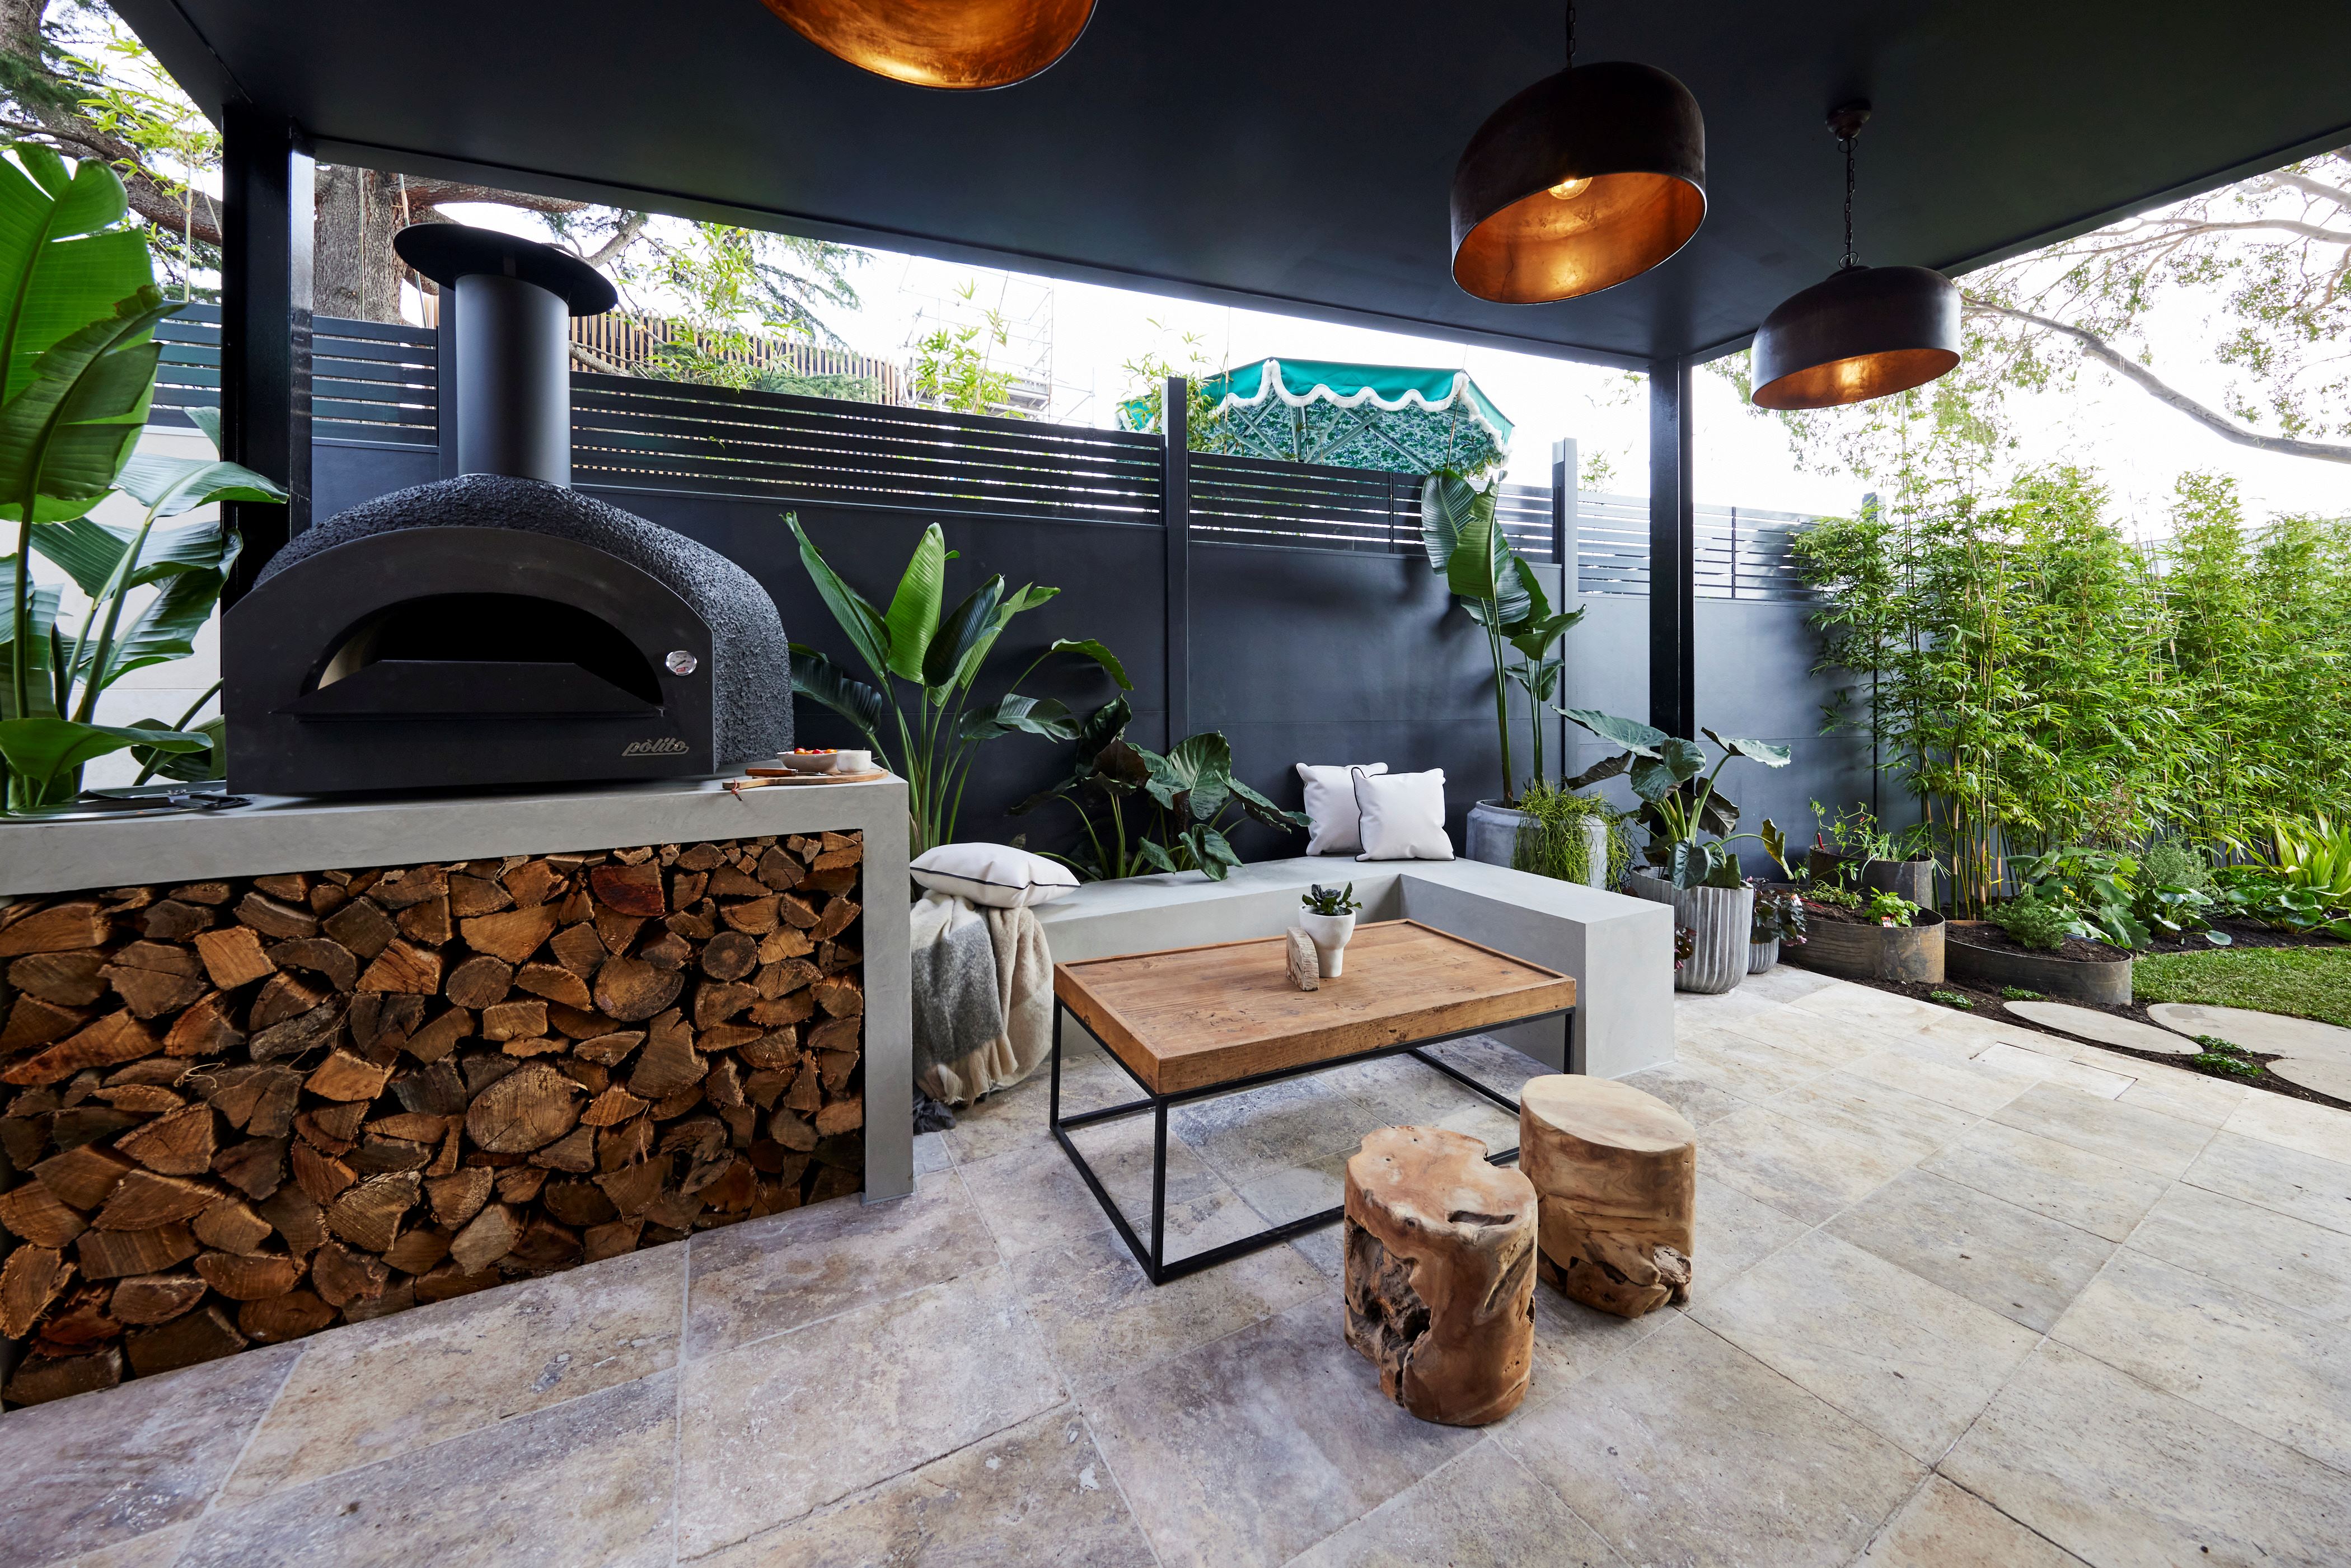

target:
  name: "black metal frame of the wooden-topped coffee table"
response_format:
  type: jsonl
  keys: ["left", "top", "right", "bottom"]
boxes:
{"left": 1048, "top": 997, "right": 1575, "bottom": 1286}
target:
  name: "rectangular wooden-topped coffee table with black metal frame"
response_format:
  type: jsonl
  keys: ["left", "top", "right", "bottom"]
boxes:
{"left": 1051, "top": 919, "right": 1575, "bottom": 1286}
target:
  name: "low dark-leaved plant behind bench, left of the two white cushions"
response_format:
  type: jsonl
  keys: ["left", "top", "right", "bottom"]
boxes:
{"left": 1011, "top": 696, "right": 1307, "bottom": 882}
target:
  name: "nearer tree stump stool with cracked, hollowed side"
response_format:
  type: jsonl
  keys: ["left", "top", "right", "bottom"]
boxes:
{"left": 1347, "top": 1126, "right": 1535, "bottom": 1427}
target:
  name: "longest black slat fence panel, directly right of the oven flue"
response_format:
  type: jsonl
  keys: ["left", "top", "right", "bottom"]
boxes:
{"left": 572, "top": 374, "right": 1159, "bottom": 524}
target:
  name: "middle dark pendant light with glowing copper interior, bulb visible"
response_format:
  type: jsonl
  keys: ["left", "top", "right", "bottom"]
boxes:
{"left": 1453, "top": 4, "right": 1707, "bottom": 306}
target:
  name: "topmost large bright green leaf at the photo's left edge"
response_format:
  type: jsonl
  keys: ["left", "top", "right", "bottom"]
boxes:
{"left": 0, "top": 143, "right": 155, "bottom": 402}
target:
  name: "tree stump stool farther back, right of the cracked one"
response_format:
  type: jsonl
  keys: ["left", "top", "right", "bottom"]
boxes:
{"left": 1519, "top": 1074, "right": 1697, "bottom": 1317}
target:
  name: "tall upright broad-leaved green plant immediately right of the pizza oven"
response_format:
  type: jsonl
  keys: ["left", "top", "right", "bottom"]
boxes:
{"left": 785, "top": 512, "right": 1133, "bottom": 853}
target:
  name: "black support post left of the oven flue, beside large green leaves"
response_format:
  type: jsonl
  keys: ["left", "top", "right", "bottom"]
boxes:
{"left": 221, "top": 104, "right": 313, "bottom": 604}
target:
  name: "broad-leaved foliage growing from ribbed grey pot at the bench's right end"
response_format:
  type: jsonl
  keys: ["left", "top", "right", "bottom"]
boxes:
{"left": 1559, "top": 708, "right": 1789, "bottom": 888}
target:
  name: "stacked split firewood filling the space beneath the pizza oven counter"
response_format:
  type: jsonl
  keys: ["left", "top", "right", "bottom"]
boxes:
{"left": 0, "top": 832, "right": 865, "bottom": 1403}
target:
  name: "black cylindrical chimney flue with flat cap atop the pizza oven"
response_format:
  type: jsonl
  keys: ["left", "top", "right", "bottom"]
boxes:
{"left": 392, "top": 223, "right": 619, "bottom": 484}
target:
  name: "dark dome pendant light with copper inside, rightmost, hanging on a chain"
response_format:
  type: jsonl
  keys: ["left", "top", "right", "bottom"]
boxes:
{"left": 1749, "top": 104, "right": 1961, "bottom": 409}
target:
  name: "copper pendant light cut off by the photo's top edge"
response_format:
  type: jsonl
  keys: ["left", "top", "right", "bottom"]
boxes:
{"left": 766, "top": 0, "right": 1093, "bottom": 92}
